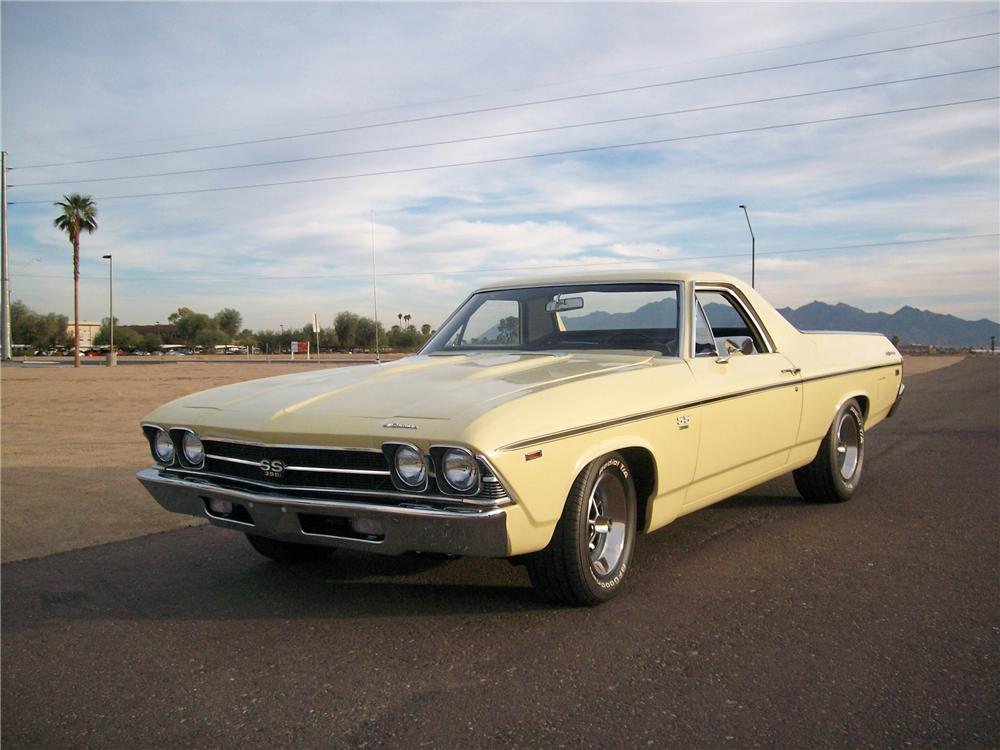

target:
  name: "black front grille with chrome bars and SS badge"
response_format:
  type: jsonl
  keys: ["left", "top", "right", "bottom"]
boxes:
{"left": 194, "top": 438, "right": 509, "bottom": 504}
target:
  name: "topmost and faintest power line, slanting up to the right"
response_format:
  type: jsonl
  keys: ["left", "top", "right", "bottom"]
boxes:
{"left": 9, "top": 10, "right": 997, "bottom": 158}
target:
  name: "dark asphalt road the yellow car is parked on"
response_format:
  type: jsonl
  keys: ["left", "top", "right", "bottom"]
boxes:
{"left": 2, "top": 358, "right": 1000, "bottom": 748}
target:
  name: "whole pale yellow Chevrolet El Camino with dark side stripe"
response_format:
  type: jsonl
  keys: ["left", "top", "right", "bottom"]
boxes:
{"left": 138, "top": 273, "right": 904, "bottom": 604}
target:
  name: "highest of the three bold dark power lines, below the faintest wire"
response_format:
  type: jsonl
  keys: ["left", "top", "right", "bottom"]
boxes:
{"left": 10, "top": 31, "right": 1000, "bottom": 169}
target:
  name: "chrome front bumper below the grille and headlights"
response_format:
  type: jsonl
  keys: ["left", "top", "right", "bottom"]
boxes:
{"left": 136, "top": 469, "right": 508, "bottom": 557}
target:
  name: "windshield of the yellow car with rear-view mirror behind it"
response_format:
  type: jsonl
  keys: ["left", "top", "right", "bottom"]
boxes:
{"left": 422, "top": 283, "right": 678, "bottom": 356}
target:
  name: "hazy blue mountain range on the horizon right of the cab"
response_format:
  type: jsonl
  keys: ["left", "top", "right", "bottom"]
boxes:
{"left": 778, "top": 302, "right": 1000, "bottom": 347}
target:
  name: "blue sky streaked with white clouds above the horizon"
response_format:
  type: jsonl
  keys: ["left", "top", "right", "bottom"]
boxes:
{"left": 2, "top": 2, "right": 1000, "bottom": 328}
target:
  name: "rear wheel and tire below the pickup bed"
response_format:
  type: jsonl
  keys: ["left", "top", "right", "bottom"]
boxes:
{"left": 792, "top": 398, "right": 865, "bottom": 503}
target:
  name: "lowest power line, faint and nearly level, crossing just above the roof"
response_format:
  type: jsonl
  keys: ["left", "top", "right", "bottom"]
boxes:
{"left": 13, "top": 232, "right": 1000, "bottom": 282}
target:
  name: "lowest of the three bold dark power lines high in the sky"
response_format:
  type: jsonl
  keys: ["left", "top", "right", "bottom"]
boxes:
{"left": 8, "top": 96, "right": 1000, "bottom": 206}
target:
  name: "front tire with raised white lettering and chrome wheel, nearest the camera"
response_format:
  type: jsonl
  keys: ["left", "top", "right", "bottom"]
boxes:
{"left": 527, "top": 453, "right": 636, "bottom": 605}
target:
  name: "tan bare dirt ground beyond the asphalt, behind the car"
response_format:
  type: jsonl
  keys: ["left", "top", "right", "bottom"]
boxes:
{"left": 0, "top": 356, "right": 962, "bottom": 562}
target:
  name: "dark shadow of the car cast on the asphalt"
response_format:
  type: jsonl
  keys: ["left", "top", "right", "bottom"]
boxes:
{"left": 3, "top": 483, "right": 802, "bottom": 630}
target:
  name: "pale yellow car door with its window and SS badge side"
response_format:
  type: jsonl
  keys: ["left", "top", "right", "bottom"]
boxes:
{"left": 685, "top": 285, "right": 802, "bottom": 505}
